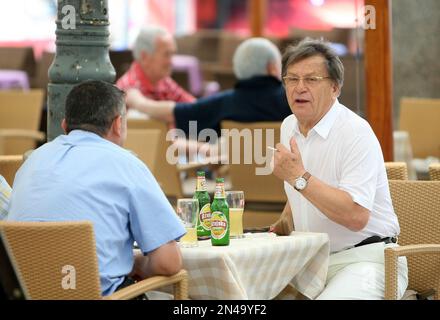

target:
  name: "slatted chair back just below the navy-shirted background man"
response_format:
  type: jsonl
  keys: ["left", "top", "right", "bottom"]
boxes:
{"left": 221, "top": 121, "right": 287, "bottom": 203}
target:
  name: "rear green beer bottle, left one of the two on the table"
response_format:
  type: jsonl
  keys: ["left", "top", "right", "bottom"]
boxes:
{"left": 193, "top": 171, "right": 211, "bottom": 240}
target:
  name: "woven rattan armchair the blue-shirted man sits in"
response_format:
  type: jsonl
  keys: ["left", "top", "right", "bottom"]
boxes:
{"left": 0, "top": 221, "right": 188, "bottom": 300}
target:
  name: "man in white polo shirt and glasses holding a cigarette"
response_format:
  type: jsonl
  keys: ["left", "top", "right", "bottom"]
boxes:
{"left": 274, "top": 39, "right": 408, "bottom": 299}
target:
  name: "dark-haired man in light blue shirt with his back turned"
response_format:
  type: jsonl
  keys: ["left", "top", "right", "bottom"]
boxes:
{"left": 7, "top": 81, "right": 185, "bottom": 295}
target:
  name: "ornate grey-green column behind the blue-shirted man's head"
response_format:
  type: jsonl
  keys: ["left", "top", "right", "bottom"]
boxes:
{"left": 47, "top": 0, "right": 116, "bottom": 141}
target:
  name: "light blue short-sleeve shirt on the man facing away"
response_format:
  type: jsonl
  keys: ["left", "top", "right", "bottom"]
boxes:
{"left": 7, "top": 130, "right": 185, "bottom": 295}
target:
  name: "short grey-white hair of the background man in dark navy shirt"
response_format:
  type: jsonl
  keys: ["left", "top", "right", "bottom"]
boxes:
{"left": 232, "top": 38, "right": 281, "bottom": 80}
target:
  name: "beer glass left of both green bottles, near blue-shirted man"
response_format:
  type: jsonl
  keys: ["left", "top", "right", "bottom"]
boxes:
{"left": 177, "top": 198, "right": 199, "bottom": 248}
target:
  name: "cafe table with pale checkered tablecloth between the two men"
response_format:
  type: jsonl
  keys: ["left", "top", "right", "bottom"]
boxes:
{"left": 181, "top": 232, "right": 330, "bottom": 300}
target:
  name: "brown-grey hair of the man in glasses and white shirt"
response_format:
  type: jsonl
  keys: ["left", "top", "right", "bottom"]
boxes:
{"left": 281, "top": 38, "right": 344, "bottom": 88}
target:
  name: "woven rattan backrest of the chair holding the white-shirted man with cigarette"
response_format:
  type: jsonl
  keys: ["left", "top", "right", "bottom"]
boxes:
{"left": 389, "top": 180, "right": 440, "bottom": 292}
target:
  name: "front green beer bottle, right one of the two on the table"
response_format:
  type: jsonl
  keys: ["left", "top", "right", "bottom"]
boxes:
{"left": 211, "top": 178, "right": 229, "bottom": 246}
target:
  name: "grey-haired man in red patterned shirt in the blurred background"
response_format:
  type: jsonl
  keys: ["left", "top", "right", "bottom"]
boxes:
{"left": 116, "top": 27, "right": 195, "bottom": 102}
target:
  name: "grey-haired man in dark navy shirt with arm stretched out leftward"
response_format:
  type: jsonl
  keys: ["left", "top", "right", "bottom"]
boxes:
{"left": 127, "top": 38, "right": 291, "bottom": 135}
